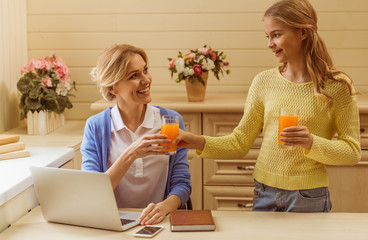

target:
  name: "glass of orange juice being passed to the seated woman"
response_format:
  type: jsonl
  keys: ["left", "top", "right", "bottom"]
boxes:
{"left": 161, "top": 115, "right": 179, "bottom": 155}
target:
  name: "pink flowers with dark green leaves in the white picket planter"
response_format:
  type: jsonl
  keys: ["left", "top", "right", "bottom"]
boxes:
{"left": 17, "top": 54, "right": 75, "bottom": 119}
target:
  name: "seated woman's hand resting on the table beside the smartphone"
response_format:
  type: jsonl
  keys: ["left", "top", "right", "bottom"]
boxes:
{"left": 139, "top": 202, "right": 170, "bottom": 225}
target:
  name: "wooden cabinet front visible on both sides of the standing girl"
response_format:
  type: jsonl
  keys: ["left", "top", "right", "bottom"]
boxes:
{"left": 193, "top": 110, "right": 368, "bottom": 212}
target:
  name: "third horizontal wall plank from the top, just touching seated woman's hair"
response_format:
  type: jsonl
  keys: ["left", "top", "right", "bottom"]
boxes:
{"left": 28, "top": 31, "right": 368, "bottom": 52}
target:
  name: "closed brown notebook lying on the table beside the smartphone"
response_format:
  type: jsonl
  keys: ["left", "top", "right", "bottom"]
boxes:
{"left": 170, "top": 210, "right": 216, "bottom": 232}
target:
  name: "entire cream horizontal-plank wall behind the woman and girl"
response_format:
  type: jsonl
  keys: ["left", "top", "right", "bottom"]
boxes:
{"left": 27, "top": 0, "right": 368, "bottom": 119}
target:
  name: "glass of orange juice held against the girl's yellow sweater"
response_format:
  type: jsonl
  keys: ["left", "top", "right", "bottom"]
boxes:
{"left": 278, "top": 108, "right": 299, "bottom": 149}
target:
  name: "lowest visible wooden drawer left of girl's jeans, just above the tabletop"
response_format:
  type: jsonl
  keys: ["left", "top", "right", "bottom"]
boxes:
{"left": 203, "top": 186, "right": 254, "bottom": 211}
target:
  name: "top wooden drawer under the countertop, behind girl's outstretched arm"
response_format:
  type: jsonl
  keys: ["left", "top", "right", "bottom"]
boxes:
{"left": 203, "top": 113, "right": 263, "bottom": 148}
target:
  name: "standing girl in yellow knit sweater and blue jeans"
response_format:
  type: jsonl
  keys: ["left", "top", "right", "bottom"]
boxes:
{"left": 174, "top": 0, "right": 361, "bottom": 212}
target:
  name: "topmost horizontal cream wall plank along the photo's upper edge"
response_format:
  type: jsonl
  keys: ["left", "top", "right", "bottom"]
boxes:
{"left": 27, "top": 0, "right": 368, "bottom": 15}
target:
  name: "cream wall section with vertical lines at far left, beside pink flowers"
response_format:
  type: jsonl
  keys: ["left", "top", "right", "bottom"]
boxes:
{"left": 0, "top": 0, "right": 27, "bottom": 133}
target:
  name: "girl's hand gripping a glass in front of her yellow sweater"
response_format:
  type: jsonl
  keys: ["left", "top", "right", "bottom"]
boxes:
{"left": 280, "top": 126, "right": 313, "bottom": 149}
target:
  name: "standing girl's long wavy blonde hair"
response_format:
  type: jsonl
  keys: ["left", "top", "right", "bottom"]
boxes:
{"left": 264, "top": 0, "right": 355, "bottom": 106}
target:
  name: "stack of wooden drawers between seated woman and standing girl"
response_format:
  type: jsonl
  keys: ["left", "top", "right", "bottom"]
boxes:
{"left": 203, "top": 112, "right": 262, "bottom": 211}
